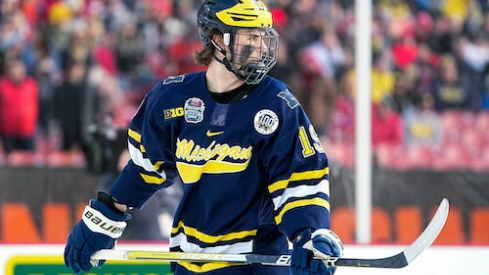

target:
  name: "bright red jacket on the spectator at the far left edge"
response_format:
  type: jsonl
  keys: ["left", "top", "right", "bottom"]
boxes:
{"left": 0, "top": 77, "right": 38, "bottom": 137}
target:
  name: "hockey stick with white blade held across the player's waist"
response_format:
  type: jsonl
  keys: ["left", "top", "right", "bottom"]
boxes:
{"left": 92, "top": 199, "right": 449, "bottom": 268}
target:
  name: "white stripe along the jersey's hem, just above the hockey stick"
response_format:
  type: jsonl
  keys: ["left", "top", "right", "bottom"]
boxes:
{"left": 170, "top": 233, "right": 253, "bottom": 253}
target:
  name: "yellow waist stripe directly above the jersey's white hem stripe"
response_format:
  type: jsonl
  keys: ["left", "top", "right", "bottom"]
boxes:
{"left": 171, "top": 221, "right": 257, "bottom": 244}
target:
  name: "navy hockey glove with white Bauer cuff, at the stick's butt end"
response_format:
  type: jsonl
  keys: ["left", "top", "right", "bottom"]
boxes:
{"left": 64, "top": 193, "right": 131, "bottom": 273}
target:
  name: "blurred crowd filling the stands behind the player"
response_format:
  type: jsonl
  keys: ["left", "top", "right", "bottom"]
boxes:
{"left": 0, "top": 0, "right": 489, "bottom": 172}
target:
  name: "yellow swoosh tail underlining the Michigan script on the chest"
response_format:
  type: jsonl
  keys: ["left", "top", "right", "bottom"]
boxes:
{"left": 177, "top": 159, "right": 250, "bottom": 184}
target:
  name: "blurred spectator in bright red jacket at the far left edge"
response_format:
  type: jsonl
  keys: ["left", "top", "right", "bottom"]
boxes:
{"left": 0, "top": 60, "right": 38, "bottom": 154}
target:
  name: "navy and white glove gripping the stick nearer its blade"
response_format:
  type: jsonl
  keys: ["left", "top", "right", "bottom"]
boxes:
{"left": 291, "top": 229, "right": 343, "bottom": 275}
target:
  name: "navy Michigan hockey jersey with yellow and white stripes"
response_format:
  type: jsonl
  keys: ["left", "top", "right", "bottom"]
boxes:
{"left": 111, "top": 72, "right": 330, "bottom": 274}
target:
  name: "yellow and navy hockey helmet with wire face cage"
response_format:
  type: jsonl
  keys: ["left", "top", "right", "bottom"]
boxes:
{"left": 197, "top": 0, "right": 279, "bottom": 85}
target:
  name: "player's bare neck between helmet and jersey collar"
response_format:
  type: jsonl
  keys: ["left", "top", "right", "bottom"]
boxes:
{"left": 206, "top": 61, "right": 244, "bottom": 93}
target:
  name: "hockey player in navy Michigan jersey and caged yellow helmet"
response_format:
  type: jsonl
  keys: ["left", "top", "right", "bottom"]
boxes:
{"left": 64, "top": 0, "right": 343, "bottom": 275}
